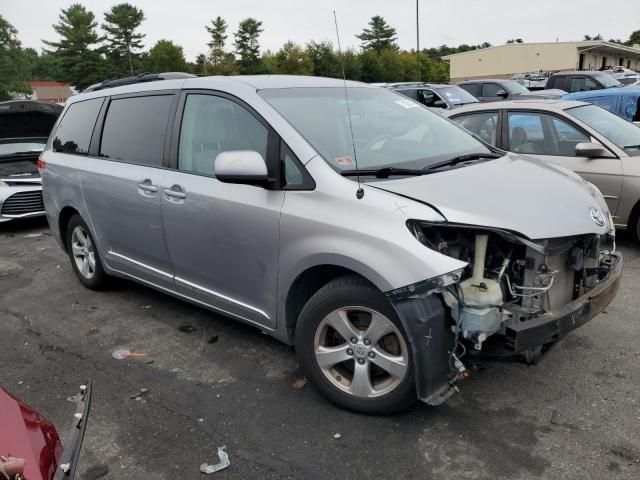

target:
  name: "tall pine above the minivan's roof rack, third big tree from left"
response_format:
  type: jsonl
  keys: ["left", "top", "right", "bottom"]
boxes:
{"left": 102, "top": 3, "right": 145, "bottom": 76}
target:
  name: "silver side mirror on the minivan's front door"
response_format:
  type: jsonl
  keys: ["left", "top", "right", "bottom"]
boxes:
{"left": 213, "top": 150, "right": 269, "bottom": 186}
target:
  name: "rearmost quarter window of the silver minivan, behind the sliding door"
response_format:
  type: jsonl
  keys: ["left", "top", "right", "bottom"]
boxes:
{"left": 52, "top": 98, "right": 104, "bottom": 155}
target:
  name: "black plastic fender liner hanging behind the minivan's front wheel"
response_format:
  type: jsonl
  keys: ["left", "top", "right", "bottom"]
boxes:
{"left": 391, "top": 294, "right": 455, "bottom": 405}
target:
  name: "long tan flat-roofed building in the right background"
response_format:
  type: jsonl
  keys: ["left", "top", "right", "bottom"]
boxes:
{"left": 442, "top": 40, "right": 640, "bottom": 82}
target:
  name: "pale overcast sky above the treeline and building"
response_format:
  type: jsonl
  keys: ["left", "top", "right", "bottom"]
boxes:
{"left": 0, "top": 0, "right": 640, "bottom": 60}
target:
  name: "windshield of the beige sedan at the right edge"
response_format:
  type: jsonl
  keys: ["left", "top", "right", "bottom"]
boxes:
{"left": 567, "top": 105, "right": 640, "bottom": 156}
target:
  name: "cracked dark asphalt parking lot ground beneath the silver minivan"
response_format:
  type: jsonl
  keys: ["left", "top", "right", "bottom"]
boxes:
{"left": 0, "top": 221, "right": 640, "bottom": 479}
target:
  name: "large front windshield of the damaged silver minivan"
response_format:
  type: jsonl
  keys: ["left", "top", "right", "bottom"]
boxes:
{"left": 259, "top": 87, "right": 490, "bottom": 171}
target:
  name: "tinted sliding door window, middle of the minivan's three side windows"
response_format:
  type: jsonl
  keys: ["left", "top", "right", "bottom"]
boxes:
{"left": 100, "top": 95, "right": 173, "bottom": 167}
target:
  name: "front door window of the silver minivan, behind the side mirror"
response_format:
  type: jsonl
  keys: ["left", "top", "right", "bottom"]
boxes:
{"left": 178, "top": 94, "right": 268, "bottom": 176}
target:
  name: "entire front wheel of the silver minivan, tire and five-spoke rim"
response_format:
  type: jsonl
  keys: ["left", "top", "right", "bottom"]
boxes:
{"left": 296, "top": 276, "right": 416, "bottom": 414}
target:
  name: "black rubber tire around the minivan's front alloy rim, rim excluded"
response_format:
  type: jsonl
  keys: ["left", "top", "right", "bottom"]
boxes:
{"left": 295, "top": 275, "right": 417, "bottom": 415}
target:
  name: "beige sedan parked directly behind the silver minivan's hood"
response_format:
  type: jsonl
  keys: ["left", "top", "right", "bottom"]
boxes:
{"left": 445, "top": 100, "right": 640, "bottom": 238}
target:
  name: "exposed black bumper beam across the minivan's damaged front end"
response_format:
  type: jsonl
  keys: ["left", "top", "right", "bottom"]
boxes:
{"left": 505, "top": 254, "right": 624, "bottom": 353}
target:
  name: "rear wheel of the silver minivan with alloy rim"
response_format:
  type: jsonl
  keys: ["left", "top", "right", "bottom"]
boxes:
{"left": 67, "top": 214, "right": 108, "bottom": 290}
